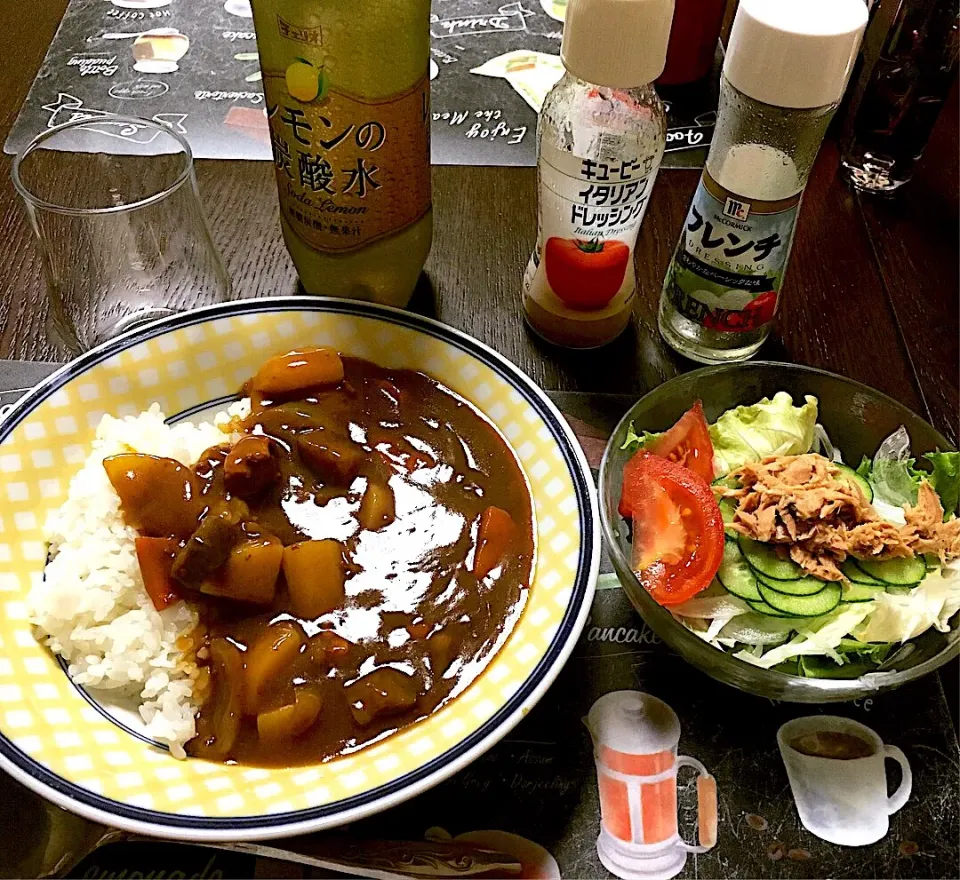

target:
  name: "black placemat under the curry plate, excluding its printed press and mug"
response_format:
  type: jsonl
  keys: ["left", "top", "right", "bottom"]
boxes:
{"left": 0, "top": 361, "right": 960, "bottom": 878}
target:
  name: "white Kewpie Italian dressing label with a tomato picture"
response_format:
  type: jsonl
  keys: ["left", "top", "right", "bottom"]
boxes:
{"left": 524, "top": 141, "right": 657, "bottom": 321}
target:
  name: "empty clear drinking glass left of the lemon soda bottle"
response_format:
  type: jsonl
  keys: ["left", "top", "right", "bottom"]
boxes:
{"left": 12, "top": 114, "right": 231, "bottom": 353}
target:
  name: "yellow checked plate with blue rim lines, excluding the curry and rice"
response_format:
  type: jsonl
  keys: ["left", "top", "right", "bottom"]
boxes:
{"left": 0, "top": 297, "right": 600, "bottom": 840}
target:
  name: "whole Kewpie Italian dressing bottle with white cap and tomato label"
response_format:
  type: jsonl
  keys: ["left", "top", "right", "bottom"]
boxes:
{"left": 523, "top": 0, "right": 673, "bottom": 348}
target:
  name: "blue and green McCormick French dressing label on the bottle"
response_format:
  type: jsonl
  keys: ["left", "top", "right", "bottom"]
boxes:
{"left": 664, "top": 169, "right": 802, "bottom": 332}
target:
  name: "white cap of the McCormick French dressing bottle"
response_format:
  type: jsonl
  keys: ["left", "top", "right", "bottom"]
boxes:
{"left": 723, "top": 0, "right": 867, "bottom": 108}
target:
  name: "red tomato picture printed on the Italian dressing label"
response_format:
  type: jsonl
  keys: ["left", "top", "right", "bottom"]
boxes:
{"left": 543, "top": 237, "right": 630, "bottom": 310}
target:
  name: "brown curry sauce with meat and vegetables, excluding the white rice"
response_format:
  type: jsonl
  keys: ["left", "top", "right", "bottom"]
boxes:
{"left": 104, "top": 349, "right": 534, "bottom": 765}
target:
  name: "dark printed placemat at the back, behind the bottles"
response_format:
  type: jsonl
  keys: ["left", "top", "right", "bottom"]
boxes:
{"left": 4, "top": 0, "right": 716, "bottom": 167}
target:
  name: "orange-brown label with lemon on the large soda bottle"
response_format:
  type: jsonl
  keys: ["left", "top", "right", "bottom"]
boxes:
{"left": 264, "top": 62, "right": 430, "bottom": 252}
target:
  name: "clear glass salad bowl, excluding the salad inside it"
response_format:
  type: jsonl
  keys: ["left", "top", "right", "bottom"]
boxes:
{"left": 600, "top": 361, "right": 960, "bottom": 703}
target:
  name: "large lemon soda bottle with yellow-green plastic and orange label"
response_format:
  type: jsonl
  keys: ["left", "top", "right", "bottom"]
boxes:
{"left": 252, "top": 0, "right": 433, "bottom": 307}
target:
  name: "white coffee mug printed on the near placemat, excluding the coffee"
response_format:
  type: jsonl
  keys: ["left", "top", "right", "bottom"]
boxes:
{"left": 777, "top": 715, "right": 913, "bottom": 846}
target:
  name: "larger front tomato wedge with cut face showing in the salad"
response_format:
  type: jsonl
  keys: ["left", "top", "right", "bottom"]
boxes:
{"left": 619, "top": 449, "right": 723, "bottom": 605}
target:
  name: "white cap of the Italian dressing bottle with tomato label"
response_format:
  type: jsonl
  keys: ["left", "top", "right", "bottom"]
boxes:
{"left": 560, "top": 0, "right": 674, "bottom": 89}
